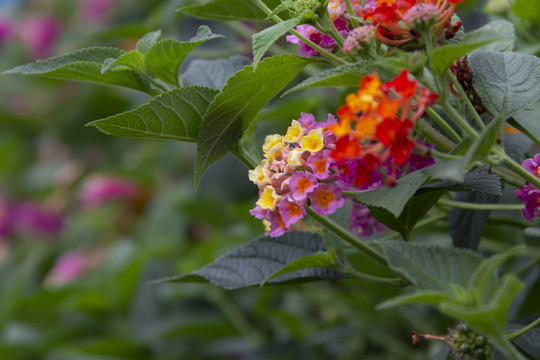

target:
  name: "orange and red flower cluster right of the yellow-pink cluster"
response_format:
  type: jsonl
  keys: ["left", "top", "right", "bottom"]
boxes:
{"left": 329, "top": 69, "right": 438, "bottom": 187}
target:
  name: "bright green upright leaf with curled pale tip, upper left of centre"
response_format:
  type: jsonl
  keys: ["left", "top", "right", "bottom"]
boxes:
{"left": 144, "top": 25, "right": 223, "bottom": 86}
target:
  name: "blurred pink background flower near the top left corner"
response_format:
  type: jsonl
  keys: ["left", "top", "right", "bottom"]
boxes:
{"left": 16, "top": 14, "right": 62, "bottom": 58}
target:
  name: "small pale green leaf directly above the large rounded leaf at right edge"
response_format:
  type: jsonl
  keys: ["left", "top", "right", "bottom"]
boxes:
{"left": 463, "top": 20, "right": 516, "bottom": 51}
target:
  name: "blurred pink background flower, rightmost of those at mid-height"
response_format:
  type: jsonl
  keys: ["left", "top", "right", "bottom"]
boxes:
{"left": 80, "top": 175, "right": 138, "bottom": 208}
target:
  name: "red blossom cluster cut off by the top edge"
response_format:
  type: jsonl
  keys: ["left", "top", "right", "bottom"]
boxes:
{"left": 361, "top": 0, "right": 465, "bottom": 46}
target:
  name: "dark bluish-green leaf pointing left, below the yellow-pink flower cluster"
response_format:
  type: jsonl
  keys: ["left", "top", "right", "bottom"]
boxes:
{"left": 150, "top": 232, "right": 346, "bottom": 289}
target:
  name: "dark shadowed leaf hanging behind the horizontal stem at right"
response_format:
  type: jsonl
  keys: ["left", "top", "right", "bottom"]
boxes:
{"left": 448, "top": 192, "right": 499, "bottom": 250}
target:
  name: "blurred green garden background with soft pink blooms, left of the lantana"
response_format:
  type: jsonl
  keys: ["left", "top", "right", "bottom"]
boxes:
{"left": 0, "top": 0, "right": 534, "bottom": 360}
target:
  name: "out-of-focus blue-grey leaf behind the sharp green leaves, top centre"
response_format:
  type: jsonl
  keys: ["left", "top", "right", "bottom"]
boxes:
{"left": 180, "top": 56, "right": 251, "bottom": 90}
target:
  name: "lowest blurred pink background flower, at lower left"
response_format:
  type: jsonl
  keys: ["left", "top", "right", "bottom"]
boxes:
{"left": 46, "top": 250, "right": 103, "bottom": 286}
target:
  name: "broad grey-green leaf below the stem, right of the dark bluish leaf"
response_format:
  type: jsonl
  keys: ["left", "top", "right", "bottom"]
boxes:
{"left": 379, "top": 241, "right": 482, "bottom": 293}
